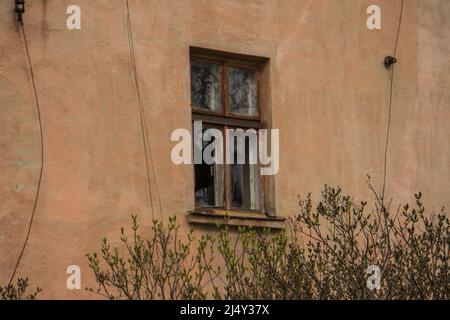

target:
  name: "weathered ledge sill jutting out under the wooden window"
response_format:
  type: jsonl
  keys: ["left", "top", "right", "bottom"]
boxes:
{"left": 187, "top": 210, "right": 286, "bottom": 229}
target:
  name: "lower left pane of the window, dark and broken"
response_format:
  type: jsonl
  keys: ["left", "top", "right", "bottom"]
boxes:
{"left": 195, "top": 129, "right": 224, "bottom": 207}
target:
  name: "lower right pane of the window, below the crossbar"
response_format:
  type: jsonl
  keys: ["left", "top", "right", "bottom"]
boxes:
{"left": 231, "top": 136, "right": 260, "bottom": 210}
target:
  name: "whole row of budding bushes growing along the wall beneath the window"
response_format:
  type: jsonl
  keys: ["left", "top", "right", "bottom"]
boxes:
{"left": 88, "top": 181, "right": 450, "bottom": 300}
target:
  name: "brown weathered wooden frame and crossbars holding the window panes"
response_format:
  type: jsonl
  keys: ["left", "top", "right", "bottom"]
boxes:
{"left": 189, "top": 47, "right": 268, "bottom": 215}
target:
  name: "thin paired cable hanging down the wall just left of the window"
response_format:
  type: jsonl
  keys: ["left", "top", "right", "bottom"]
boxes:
{"left": 125, "top": 0, "right": 162, "bottom": 218}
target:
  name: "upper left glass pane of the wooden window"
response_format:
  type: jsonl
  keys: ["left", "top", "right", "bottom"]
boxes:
{"left": 191, "top": 61, "right": 222, "bottom": 111}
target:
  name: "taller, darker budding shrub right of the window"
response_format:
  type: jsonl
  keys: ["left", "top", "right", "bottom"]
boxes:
{"left": 291, "top": 181, "right": 450, "bottom": 299}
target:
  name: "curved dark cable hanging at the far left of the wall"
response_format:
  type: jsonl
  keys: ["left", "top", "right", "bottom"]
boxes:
{"left": 8, "top": 22, "right": 44, "bottom": 285}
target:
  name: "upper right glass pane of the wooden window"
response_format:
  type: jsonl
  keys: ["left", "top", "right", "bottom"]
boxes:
{"left": 228, "top": 67, "right": 258, "bottom": 116}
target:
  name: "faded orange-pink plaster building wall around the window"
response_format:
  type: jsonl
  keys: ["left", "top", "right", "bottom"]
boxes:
{"left": 0, "top": 0, "right": 450, "bottom": 299}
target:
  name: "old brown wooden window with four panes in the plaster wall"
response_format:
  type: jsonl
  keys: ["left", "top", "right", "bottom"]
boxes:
{"left": 190, "top": 48, "right": 267, "bottom": 212}
